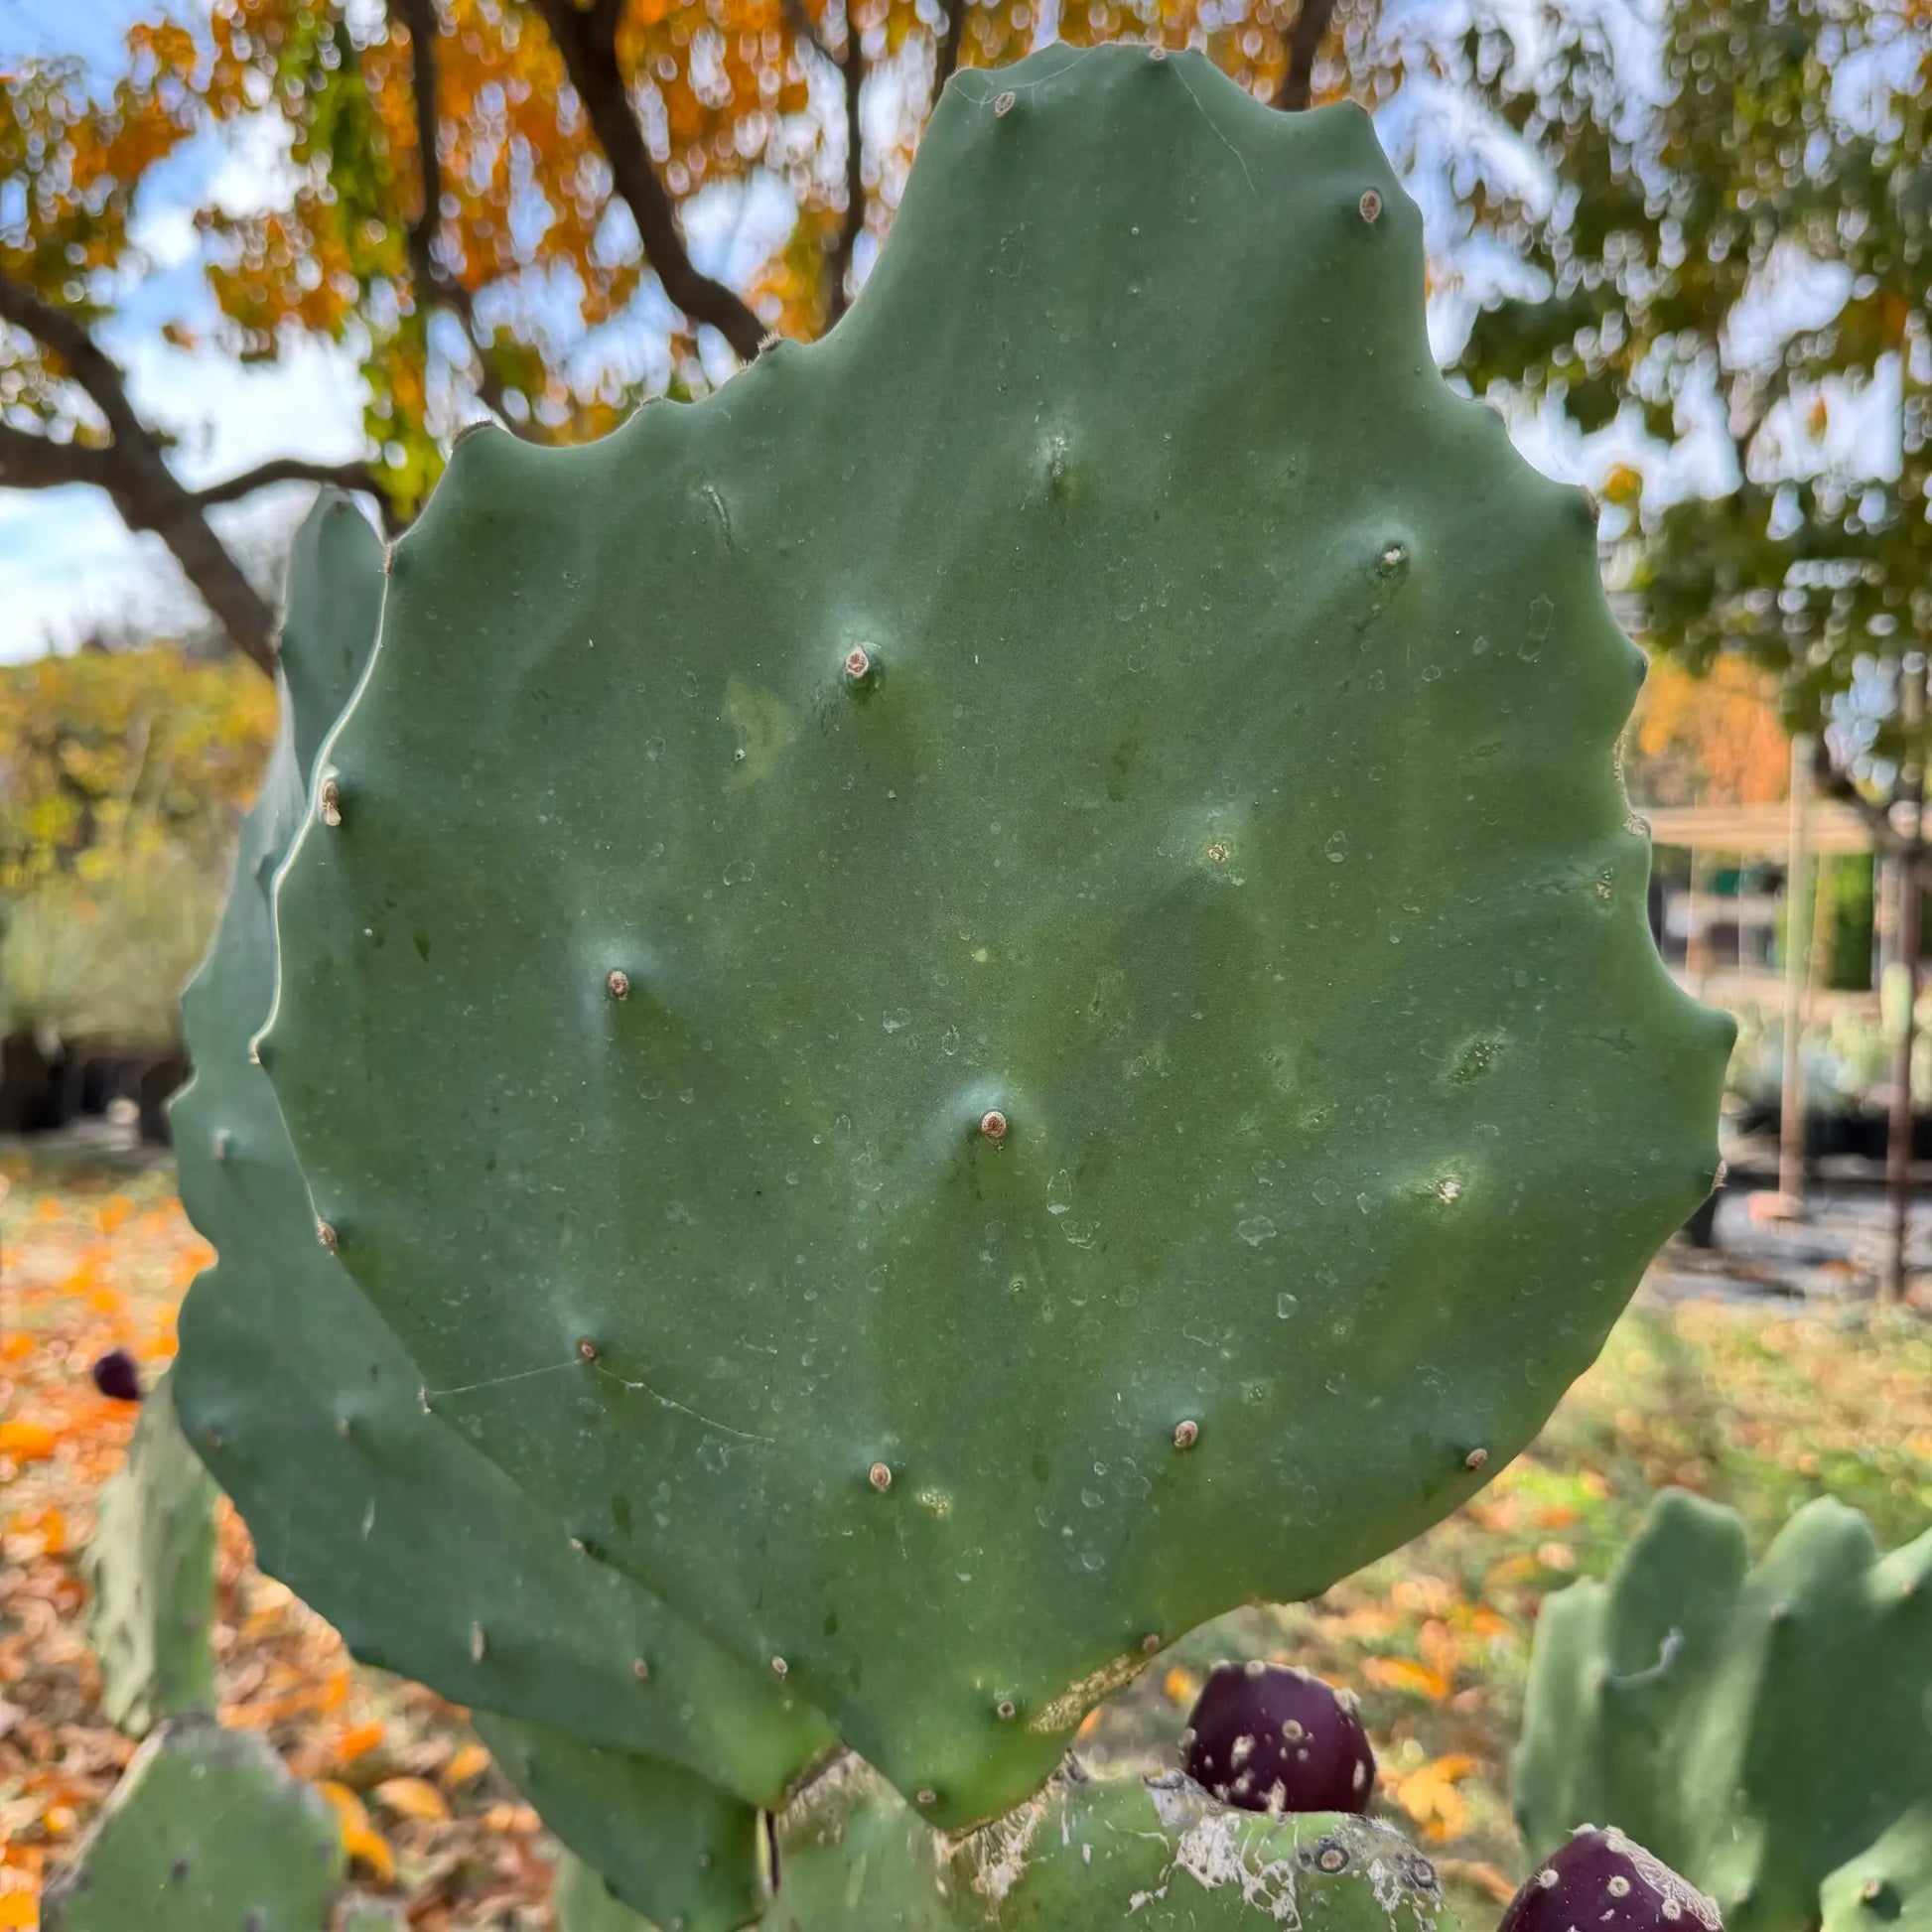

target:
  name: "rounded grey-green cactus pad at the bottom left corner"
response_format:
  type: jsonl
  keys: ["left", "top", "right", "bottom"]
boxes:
{"left": 41, "top": 1718, "right": 344, "bottom": 1932}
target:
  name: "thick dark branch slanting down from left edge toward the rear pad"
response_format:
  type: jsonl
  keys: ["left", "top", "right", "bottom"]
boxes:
{"left": 0, "top": 274, "right": 274, "bottom": 676}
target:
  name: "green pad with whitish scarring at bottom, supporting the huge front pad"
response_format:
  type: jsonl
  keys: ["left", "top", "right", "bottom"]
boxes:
{"left": 765, "top": 1760, "right": 1450, "bottom": 1932}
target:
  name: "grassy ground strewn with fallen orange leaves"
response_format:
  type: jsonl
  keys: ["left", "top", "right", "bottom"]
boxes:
{"left": 0, "top": 1158, "right": 1932, "bottom": 1932}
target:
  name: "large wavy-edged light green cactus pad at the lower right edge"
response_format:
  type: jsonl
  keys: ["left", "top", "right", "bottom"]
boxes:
{"left": 1515, "top": 1491, "right": 1932, "bottom": 1932}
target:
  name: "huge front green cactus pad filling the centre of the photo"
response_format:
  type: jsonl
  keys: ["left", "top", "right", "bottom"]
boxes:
{"left": 261, "top": 47, "right": 1731, "bottom": 1826}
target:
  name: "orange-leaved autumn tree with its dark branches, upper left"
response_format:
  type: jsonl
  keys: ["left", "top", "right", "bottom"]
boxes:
{"left": 0, "top": 0, "right": 1339, "bottom": 668}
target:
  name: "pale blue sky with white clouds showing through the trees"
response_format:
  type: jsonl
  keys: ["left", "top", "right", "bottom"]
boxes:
{"left": 0, "top": 0, "right": 1895, "bottom": 659}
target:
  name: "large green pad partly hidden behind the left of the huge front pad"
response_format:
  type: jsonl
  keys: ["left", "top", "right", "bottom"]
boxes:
{"left": 170, "top": 498, "right": 831, "bottom": 1803}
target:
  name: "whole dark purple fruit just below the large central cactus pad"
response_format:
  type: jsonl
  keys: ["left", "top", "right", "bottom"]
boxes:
{"left": 1180, "top": 1662, "right": 1376, "bottom": 1812}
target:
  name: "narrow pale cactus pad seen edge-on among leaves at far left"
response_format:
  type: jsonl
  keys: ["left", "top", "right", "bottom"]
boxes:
{"left": 83, "top": 1376, "right": 214, "bottom": 1736}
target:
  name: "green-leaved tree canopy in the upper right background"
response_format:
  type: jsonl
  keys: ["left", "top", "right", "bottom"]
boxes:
{"left": 1458, "top": 0, "right": 1932, "bottom": 815}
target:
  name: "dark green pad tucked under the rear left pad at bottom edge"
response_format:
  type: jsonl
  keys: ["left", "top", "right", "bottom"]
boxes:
{"left": 474, "top": 1712, "right": 759, "bottom": 1932}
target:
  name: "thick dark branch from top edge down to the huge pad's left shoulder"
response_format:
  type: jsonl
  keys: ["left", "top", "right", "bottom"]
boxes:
{"left": 531, "top": 0, "right": 765, "bottom": 361}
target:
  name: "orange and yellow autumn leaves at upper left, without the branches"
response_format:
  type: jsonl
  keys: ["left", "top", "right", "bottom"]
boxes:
{"left": 0, "top": 0, "right": 1348, "bottom": 514}
